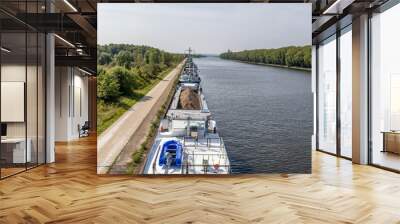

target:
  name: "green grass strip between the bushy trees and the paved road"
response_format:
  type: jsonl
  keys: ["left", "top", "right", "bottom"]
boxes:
{"left": 97, "top": 65, "right": 176, "bottom": 135}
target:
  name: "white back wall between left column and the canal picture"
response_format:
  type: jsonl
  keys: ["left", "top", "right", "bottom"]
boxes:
{"left": 55, "top": 67, "right": 88, "bottom": 141}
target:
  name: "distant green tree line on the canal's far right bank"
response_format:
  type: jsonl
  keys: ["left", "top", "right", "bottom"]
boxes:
{"left": 220, "top": 45, "right": 311, "bottom": 68}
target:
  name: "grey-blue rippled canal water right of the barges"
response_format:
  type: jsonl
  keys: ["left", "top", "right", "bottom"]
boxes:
{"left": 194, "top": 57, "right": 313, "bottom": 173}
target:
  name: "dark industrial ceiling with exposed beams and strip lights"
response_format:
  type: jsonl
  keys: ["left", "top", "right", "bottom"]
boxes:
{"left": 0, "top": 0, "right": 387, "bottom": 72}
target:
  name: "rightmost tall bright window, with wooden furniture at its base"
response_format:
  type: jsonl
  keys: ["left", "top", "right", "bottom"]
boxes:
{"left": 370, "top": 4, "right": 400, "bottom": 170}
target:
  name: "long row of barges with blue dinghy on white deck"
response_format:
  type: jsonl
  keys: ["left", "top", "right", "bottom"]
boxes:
{"left": 143, "top": 50, "right": 230, "bottom": 175}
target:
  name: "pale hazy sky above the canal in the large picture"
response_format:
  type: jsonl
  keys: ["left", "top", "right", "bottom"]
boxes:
{"left": 97, "top": 3, "right": 311, "bottom": 53}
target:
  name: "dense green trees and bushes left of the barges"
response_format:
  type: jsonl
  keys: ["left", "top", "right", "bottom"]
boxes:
{"left": 97, "top": 44, "right": 183, "bottom": 101}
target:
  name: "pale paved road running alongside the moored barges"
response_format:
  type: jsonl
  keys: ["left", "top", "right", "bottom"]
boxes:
{"left": 97, "top": 62, "right": 183, "bottom": 174}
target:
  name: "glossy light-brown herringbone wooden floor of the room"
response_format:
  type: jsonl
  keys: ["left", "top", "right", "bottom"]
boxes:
{"left": 0, "top": 138, "right": 400, "bottom": 224}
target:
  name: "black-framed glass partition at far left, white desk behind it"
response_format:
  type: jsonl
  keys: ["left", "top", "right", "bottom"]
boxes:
{"left": 0, "top": 1, "right": 46, "bottom": 178}
